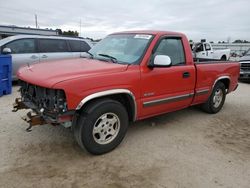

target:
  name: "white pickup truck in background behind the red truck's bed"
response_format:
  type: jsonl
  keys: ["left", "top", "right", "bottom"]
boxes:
{"left": 192, "top": 42, "right": 230, "bottom": 61}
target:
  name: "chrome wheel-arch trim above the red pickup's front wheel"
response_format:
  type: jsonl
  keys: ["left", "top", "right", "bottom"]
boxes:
{"left": 76, "top": 89, "right": 137, "bottom": 121}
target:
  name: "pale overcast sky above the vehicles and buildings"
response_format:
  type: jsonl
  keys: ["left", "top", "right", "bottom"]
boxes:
{"left": 0, "top": 0, "right": 250, "bottom": 42}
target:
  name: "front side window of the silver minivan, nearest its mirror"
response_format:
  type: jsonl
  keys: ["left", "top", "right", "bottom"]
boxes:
{"left": 3, "top": 39, "right": 36, "bottom": 54}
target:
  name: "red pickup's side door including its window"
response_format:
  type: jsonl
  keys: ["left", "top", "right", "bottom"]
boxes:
{"left": 141, "top": 37, "right": 195, "bottom": 117}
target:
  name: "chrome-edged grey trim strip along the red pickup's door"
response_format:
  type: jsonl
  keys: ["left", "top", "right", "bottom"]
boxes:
{"left": 143, "top": 93, "right": 194, "bottom": 107}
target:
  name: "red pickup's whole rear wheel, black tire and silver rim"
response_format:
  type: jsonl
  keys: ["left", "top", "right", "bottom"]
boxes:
{"left": 201, "top": 82, "right": 226, "bottom": 114}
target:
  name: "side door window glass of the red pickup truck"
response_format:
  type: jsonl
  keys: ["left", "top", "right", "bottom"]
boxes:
{"left": 155, "top": 38, "right": 185, "bottom": 65}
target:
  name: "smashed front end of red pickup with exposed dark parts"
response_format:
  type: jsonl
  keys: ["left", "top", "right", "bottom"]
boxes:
{"left": 12, "top": 81, "right": 74, "bottom": 131}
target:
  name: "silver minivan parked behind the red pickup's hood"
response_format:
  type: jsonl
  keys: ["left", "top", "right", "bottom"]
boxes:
{"left": 0, "top": 35, "right": 93, "bottom": 80}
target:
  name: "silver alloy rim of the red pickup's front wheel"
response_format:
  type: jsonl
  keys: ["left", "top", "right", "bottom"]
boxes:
{"left": 92, "top": 112, "right": 120, "bottom": 145}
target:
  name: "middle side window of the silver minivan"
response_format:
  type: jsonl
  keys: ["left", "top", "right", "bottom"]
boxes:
{"left": 39, "top": 39, "right": 68, "bottom": 53}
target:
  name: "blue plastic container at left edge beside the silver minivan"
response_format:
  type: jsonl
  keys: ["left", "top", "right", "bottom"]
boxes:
{"left": 0, "top": 55, "right": 12, "bottom": 96}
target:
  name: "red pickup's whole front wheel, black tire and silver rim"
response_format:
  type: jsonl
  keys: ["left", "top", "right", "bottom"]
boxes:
{"left": 73, "top": 99, "right": 129, "bottom": 155}
